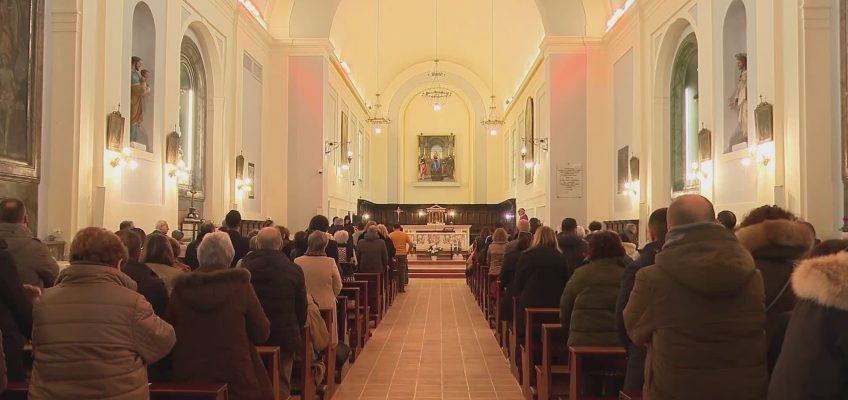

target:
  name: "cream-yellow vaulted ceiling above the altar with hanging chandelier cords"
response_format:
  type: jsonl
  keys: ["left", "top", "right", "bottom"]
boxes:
{"left": 250, "top": 0, "right": 608, "bottom": 101}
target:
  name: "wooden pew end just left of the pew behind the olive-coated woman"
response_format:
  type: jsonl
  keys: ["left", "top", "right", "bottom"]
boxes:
{"left": 536, "top": 324, "right": 571, "bottom": 400}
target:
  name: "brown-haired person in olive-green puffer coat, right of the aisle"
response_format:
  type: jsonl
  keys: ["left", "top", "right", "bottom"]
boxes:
{"left": 559, "top": 231, "right": 629, "bottom": 346}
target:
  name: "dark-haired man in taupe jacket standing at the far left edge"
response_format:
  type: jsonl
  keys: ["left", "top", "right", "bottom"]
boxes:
{"left": 0, "top": 198, "right": 59, "bottom": 288}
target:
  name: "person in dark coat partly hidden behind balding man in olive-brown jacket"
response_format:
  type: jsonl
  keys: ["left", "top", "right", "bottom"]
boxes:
{"left": 615, "top": 208, "right": 668, "bottom": 391}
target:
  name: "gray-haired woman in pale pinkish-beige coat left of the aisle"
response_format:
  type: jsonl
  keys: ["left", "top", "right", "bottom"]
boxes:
{"left": 294, "top": 231, "right": 342, "bottom": 343}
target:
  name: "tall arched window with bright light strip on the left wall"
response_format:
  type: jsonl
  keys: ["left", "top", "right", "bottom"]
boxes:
{"left": 179, "top": 36, "right": 206, "bottom": 205}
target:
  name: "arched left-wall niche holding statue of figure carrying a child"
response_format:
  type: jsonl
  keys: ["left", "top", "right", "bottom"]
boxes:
{"left": 128, "top": 2, "right": 156, "bottom": 153}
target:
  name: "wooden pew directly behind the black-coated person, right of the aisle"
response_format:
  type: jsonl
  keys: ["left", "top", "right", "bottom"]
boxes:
{"left": 521, "top": 308, "right": 559, "bottom": 400}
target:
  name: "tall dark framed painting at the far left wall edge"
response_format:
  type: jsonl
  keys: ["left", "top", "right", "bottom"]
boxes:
{"left": 0, "top": 0, "right": 44, "bottom": 182}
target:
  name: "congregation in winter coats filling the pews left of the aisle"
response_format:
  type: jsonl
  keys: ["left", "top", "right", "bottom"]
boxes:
{"left": 0, "top": 199, "right": 412, "bottom": 400}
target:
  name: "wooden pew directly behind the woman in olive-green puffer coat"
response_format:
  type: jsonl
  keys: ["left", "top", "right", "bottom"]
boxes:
{"left": 568, "top": 347, "right": 627, "bottom": 400}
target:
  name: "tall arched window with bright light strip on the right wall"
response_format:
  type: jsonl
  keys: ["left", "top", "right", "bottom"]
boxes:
{"left": 670, "top": 33, "right": 700, "bottom": 192}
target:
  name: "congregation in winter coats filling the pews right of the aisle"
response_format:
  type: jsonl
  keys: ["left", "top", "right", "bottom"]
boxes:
{"left": 468, "top": 195, "right": 848, "bottom": 400}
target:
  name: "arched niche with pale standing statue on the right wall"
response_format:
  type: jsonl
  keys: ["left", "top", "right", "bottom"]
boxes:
{"left": 721, "top": 0, "right": 751, "bottom": 153}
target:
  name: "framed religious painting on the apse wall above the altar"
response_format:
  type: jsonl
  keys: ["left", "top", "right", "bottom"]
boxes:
{"left": 416, "top": 133, "right": 457, "bottom": 182}
